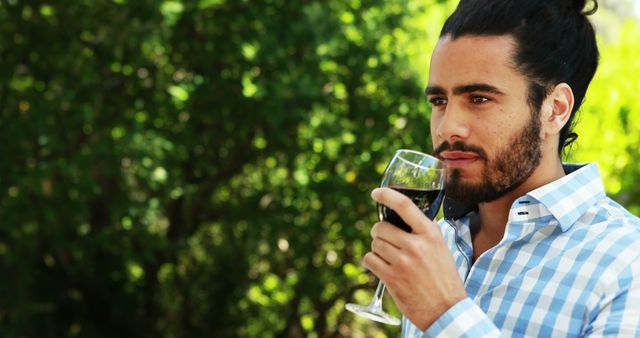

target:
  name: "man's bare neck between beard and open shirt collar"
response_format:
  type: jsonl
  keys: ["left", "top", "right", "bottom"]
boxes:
{"left": 473, "top": 158, "right": 565, "bottom": 261}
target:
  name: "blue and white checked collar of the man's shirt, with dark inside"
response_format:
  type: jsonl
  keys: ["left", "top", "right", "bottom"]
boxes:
{"left": 443, "top": 163, "right": 606, "bottom": 231}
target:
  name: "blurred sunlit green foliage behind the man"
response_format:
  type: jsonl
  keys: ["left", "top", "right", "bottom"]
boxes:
{"left": 0, "top": 0, "right": 640, "bottom": 338}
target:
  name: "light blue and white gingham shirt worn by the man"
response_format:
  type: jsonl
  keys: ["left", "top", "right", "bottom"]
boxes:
{"left": 402, "top": 164, "right": 640, "bottom": 338}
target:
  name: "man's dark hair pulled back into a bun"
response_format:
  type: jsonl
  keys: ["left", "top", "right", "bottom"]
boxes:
{"left": 440, "top": 0, "right": 599, "bottom": 154}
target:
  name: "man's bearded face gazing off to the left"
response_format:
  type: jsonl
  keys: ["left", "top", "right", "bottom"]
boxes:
{"left": 426, "top": 36, "right": 542, "bottom": 204}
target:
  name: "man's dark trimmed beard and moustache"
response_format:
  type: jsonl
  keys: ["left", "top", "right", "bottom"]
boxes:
{"left": 435, "top": 113, "right": 542, "bottom": 205}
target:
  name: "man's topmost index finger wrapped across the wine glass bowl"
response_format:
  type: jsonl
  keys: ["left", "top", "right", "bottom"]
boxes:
{"left": 371, "top": 188, "right": 431, "bottom": 234}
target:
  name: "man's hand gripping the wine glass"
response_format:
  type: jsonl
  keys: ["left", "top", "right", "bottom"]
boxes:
{"left": 363, "top": 188, "right": 467, "bottom": 331}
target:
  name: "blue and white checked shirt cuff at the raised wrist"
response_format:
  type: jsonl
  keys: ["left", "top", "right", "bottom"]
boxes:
{"left": 403, "top": 298, "right": 502, "bottom": 338}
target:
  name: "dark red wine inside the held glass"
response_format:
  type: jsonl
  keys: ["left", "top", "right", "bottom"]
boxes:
{"left": 378, "top": 187, "right": 444, "bottom": 232}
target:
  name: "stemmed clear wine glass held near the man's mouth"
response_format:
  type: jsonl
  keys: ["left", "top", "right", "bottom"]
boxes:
{"left": 345, "top": 149, "right": 445, "bottom": 325}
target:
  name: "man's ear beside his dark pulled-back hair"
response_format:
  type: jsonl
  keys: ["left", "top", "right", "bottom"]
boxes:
{"left": 540, "top": 82, "right": 574, "bottom": 136}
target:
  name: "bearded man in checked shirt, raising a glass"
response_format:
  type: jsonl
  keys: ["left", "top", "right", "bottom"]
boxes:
{"left": 364, "top": 0, "right": 640, "bottom": 337}
